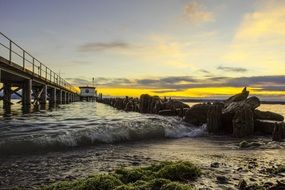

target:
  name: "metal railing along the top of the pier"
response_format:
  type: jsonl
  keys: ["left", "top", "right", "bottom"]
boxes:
{"left": 0, "top": 32, "right": 78, "bottom": 93}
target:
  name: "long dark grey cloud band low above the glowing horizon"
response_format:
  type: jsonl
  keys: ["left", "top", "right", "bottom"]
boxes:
{"left": 68, "top": 75, "right": 285, "bottom": 93}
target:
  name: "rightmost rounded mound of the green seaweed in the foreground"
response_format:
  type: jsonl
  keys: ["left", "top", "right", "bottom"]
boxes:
{"left": 157, "top": 161, "right": 201, "bottom": 182}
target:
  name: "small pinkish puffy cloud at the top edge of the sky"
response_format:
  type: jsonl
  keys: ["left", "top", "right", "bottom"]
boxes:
{"left": 184, "top": 1, "right": 214, "bottom": 24}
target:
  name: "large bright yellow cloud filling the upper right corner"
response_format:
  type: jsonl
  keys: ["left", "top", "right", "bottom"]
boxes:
{"left": 224, "top": 0, "right": 285, "bottom": 75}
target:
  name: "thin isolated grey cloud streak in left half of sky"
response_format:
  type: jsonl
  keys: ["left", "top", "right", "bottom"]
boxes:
{"left": 78, "top": 41, "right": 131, "bottom": 52}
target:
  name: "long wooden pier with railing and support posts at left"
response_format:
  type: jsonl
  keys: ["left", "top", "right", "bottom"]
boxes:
{"left": 0, "top": 32, "right": 80, "bottom": 110}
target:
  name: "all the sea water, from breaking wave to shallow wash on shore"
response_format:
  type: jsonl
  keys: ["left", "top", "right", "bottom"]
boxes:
{"left": 0, "top": 102, "right": 285, "bottom": 189}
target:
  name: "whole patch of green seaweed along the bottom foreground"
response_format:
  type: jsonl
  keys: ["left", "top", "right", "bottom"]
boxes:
{"left": 41, "top": 161, "right": 201, "bottom": 190}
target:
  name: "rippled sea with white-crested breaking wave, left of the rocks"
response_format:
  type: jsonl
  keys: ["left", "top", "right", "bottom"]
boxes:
{"left": 0, "top": 102, "right": 206, "bottom": 155}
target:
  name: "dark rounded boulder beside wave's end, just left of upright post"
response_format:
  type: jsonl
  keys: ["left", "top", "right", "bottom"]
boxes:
{"left": 184, "top": 104, "right": 211, "bottom": 126}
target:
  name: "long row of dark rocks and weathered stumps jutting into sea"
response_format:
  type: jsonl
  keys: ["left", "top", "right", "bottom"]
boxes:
{"left": 97, "top": 87, "right": 285, "bottom": 141}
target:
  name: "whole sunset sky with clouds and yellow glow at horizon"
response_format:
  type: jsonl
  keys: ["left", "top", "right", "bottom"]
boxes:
{"left": 0, "top": 0, "right": 285, "bottom": 99}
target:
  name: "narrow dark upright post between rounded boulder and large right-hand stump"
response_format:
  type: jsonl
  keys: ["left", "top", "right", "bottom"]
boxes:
{"left": 207, "top": 104, "right": 223, "bottom": 133}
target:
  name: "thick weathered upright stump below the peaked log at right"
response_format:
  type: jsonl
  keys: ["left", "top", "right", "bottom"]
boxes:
{"left": 233, "top": 107, "right": 254, "bottom": 138}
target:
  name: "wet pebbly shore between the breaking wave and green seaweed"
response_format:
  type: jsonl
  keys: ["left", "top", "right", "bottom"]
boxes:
{"left": 0, "top": 137, "right": 285, "bottom": 189}
